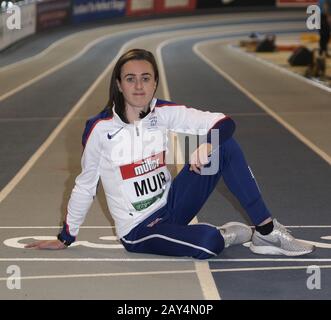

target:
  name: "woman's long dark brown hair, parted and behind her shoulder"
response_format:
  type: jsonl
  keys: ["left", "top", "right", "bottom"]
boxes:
{"left": 105, "top": 49, "right": 159, "bottom": 123}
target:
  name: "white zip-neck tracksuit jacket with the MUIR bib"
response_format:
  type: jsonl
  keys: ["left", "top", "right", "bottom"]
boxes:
{"left": 65, "top": 98, "right": 230, "bottom": 238}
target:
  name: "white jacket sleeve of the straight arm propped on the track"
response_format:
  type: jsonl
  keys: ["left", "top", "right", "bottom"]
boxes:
{"left": 61, "top": 122, "right": 102, "bottom": 243}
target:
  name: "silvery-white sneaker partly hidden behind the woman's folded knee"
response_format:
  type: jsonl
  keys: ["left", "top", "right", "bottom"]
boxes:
{"left": 219, "top": 222, "right": 253, "bottom": 248}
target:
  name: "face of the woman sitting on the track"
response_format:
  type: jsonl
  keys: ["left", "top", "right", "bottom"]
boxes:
{"left": 117, "top": 60, "right": 157, "bottom": 109}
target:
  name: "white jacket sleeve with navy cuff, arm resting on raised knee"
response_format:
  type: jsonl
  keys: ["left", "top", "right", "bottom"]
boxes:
{"left": 160, "top": 105, "right": 235, "bottom": 143}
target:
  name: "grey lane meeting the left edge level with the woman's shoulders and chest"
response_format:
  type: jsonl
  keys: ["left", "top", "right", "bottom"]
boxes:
{"left": 0, "top": 13, "right": 306, "bottom": 192}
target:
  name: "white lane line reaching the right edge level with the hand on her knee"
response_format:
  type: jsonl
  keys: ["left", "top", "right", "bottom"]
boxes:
{"left": 193, "top": 40, "right": 331, "bottom": 164}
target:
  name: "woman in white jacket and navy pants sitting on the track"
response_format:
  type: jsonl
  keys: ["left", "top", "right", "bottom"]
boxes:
{"left": 26, "top": 49, "right": 314, "bottom": 259}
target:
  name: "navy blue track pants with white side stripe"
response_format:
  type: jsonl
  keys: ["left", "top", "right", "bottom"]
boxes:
{"left": 121, "top": 138, "right": 270, "bottom": 259}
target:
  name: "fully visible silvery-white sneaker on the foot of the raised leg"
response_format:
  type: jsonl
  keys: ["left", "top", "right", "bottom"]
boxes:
{"left": 249, "top": 219, "right": 315, "bottom": 256}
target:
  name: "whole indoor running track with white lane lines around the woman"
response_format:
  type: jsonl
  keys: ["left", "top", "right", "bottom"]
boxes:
{"left": 0, "top": 13, "right": 331, "bottom": 300}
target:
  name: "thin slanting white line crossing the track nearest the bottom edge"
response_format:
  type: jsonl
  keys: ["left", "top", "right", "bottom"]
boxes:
{"left": 0, "top": 265, "right": 331, "bottom": 281}
